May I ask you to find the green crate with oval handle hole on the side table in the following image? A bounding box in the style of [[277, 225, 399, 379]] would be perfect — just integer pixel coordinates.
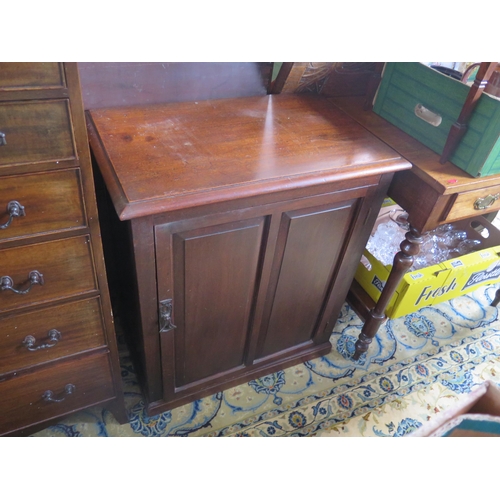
[[373, 63, 500, 177]]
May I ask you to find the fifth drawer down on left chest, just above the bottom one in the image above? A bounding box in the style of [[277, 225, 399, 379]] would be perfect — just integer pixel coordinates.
[[0, 297, 106, 374]]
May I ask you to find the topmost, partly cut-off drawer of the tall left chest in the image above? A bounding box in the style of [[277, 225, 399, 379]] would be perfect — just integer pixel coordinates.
[[0, 62, 65, 90]]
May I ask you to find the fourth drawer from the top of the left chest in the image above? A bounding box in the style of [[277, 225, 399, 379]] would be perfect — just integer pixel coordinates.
[[0, 235, 97, 312]]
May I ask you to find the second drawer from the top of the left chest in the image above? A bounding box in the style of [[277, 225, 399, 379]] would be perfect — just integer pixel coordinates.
[[0, 99, 76, 166]]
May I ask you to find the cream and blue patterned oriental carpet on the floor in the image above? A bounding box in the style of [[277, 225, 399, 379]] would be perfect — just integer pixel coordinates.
[[34, 286, 500, 437]]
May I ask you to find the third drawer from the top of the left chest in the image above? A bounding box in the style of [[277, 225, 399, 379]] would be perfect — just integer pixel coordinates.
[[0, 169, 86, 242]]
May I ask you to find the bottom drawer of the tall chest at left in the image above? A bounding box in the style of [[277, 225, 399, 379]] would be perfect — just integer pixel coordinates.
[[0, 353, 114, 434]]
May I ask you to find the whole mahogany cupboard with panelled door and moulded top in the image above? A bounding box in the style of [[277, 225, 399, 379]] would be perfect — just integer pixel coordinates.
[[87, 95, 410, 414]]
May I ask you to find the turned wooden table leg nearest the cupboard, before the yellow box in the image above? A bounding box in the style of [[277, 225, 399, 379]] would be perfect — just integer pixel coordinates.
[[353, 226, 422, 359]]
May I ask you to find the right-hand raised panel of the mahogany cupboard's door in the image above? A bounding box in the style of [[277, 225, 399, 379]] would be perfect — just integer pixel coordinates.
[[257, 201, 356, 358]]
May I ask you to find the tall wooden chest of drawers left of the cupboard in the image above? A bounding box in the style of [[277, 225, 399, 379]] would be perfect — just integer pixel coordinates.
[[0, 63, 127, 435]]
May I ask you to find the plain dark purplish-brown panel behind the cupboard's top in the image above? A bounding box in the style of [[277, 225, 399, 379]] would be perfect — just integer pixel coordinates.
[[78, 62, 272, 109]]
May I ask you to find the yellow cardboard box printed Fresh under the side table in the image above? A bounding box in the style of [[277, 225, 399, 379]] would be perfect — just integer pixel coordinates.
[[355, 217, 500, 318]]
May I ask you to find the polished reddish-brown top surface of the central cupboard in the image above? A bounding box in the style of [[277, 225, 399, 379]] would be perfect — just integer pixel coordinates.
[[88, 95, 411, 219]]
